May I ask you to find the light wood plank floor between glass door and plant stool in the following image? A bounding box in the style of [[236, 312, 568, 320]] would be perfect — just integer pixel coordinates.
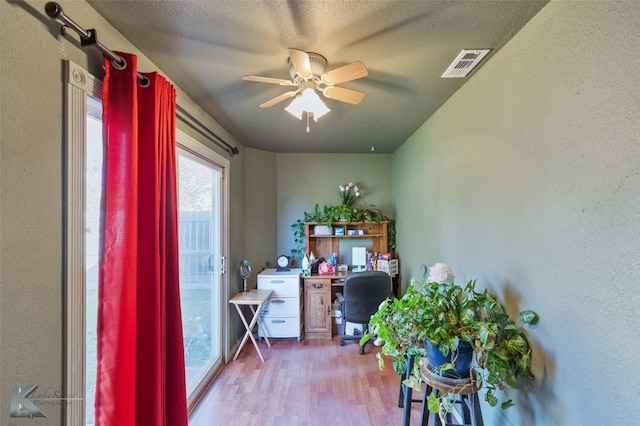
[[189, 337, 421, 426]]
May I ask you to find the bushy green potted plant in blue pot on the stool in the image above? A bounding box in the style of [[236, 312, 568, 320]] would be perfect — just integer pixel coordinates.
[[362, 263, 538, 417]]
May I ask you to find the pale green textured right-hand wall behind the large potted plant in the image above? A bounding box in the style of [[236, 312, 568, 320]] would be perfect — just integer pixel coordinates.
[[393, 1, 640, 426]]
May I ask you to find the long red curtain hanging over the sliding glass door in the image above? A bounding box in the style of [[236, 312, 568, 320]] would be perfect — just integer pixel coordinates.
[[95, 53, 187, 426]]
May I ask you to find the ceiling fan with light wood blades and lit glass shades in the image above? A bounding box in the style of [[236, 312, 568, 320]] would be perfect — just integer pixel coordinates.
[[243, 49, 368, 127]]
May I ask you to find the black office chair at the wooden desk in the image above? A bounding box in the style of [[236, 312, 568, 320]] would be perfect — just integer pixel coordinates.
[[336, 271, 393, 355]]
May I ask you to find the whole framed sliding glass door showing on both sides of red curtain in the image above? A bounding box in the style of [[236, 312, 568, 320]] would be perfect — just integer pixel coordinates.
[[69, 62, 229, 426]]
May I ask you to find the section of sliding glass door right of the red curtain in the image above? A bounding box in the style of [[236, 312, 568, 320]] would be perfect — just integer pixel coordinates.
[[177, 136, 225, 405]]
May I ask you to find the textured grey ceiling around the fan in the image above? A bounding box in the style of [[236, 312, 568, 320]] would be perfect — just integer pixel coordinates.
[[86, 0, 546, 153]]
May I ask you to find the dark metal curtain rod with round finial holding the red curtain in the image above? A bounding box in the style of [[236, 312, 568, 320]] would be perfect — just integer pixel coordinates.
[[44, 1, 240, 155]]
